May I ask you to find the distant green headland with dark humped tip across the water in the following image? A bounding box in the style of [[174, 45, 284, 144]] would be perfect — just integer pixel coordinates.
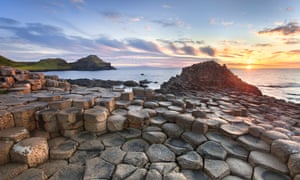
[[0, 55, 116, 71]]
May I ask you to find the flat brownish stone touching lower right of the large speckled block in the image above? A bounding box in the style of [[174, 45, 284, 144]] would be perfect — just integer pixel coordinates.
[[37, 160, 68, 178]]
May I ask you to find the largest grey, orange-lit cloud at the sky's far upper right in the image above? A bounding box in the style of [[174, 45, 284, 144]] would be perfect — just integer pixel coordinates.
[[258, 22, 300, 36]]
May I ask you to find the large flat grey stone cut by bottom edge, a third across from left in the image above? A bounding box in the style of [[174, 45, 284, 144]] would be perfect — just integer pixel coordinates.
[[83, 157, 115, 180]]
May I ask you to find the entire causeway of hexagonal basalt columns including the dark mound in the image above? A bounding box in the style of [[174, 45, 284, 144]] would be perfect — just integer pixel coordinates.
[[0, 62, 300, 180]]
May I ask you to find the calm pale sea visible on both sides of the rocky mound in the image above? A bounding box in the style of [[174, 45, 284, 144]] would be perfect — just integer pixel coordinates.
[[43, 66, 300, 104]]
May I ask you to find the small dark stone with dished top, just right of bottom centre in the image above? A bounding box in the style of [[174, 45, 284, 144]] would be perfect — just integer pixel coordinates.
[[165, 138, 193, 155]]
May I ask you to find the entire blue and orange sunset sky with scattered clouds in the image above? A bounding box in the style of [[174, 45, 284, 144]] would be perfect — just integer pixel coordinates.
[[0, 0, 300, 69]]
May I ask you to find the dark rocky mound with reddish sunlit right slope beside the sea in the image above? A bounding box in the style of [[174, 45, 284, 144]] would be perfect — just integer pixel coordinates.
[[161, 61, 262, 95]]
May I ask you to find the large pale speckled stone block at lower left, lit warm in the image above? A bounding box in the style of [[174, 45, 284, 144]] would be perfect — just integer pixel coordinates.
[[10, 137, 49, 167]]
